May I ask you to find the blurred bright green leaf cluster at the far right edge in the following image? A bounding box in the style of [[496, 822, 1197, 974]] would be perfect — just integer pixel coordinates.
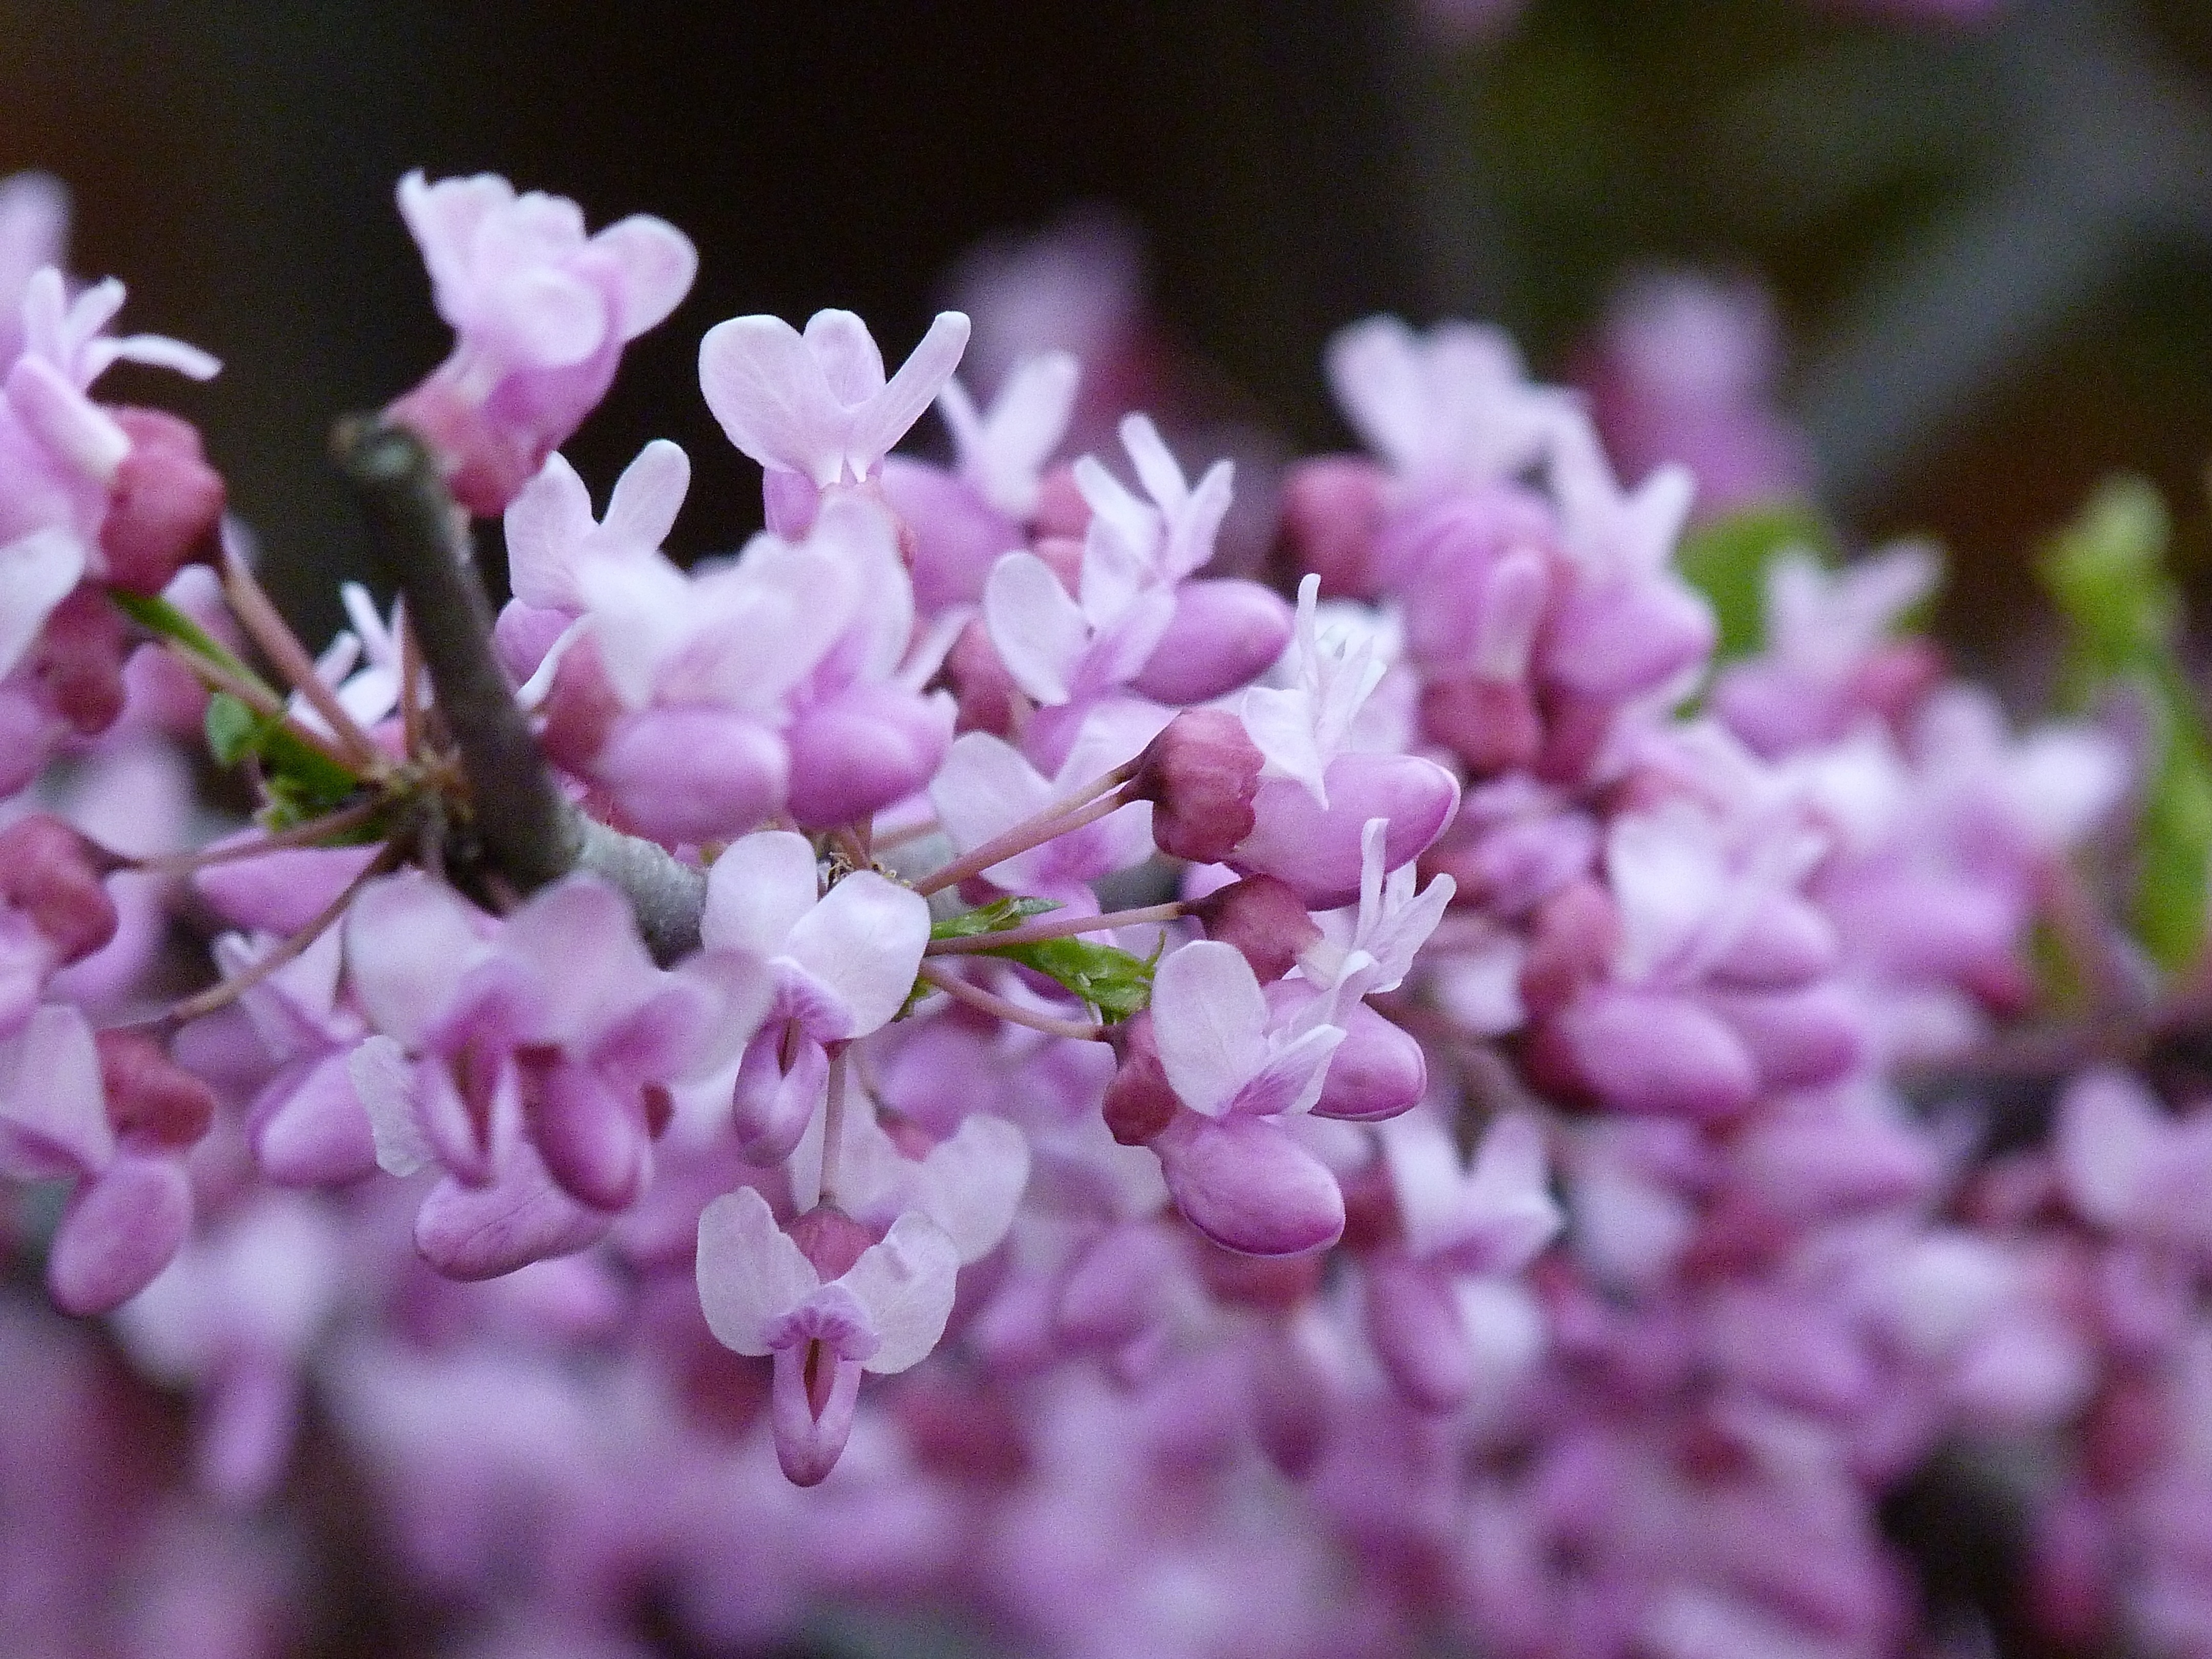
[[2039, 478, 2212, 971]]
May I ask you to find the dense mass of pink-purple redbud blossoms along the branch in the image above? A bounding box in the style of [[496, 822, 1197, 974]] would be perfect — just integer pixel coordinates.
[[0, 175, 2212, 1659]]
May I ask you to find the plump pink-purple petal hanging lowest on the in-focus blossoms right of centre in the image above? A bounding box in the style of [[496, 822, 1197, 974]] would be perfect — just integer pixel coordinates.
[[1153, 1113, 1345, 1257]]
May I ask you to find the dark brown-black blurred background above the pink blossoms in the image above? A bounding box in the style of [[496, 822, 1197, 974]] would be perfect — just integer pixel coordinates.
[[0, 0, 2212, 676]]
